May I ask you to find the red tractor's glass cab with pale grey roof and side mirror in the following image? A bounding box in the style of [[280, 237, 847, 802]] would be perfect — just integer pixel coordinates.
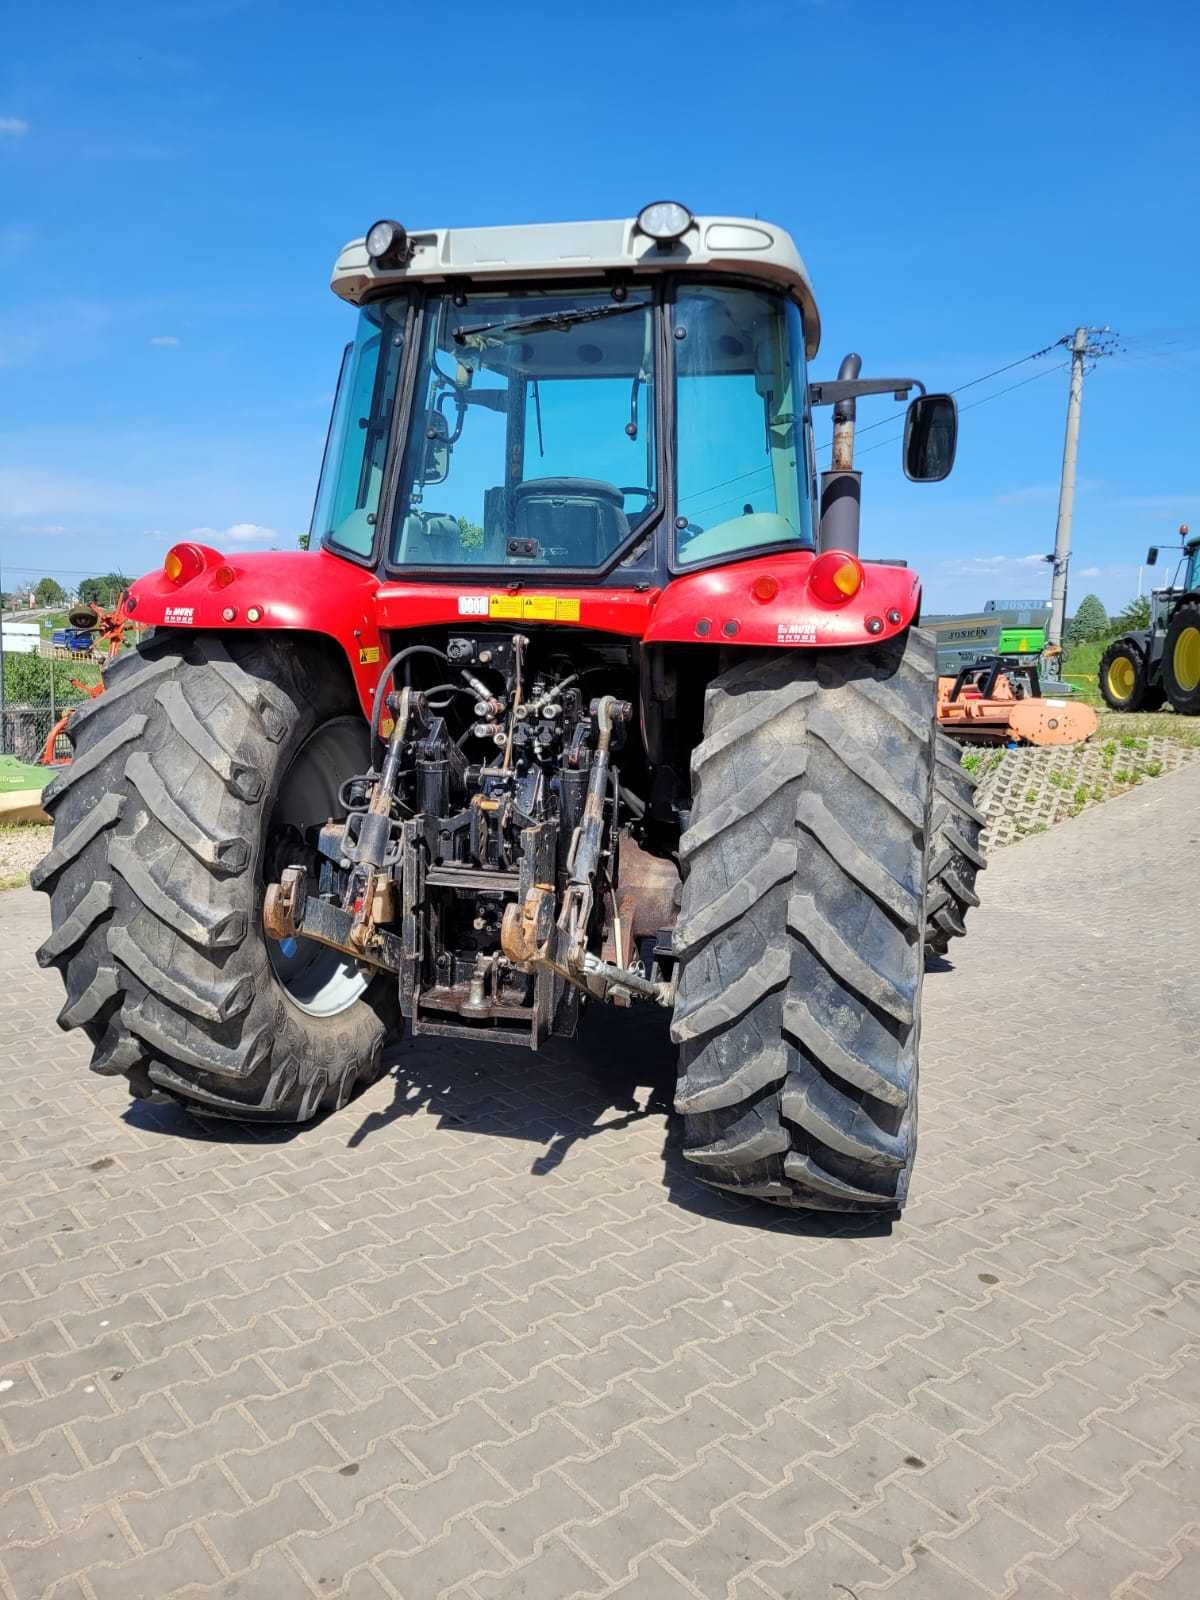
[[312, 203, 952, 587]]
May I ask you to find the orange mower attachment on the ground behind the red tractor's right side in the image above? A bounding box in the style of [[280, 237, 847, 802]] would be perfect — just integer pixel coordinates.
[[938, 656, 1099, 744]]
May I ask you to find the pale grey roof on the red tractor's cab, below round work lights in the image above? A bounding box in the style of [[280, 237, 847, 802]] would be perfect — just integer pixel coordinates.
[[330, 216, 821, 360]]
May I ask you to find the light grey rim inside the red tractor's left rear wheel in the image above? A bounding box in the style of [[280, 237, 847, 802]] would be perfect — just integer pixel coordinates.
[[264, 717, 370, 1016]]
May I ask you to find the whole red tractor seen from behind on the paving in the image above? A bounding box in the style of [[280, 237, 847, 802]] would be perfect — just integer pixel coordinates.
[[34, 202, 981, 1211]]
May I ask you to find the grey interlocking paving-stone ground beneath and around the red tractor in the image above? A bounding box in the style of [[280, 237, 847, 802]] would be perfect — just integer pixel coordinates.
[[0, 766, 1200, 1600]]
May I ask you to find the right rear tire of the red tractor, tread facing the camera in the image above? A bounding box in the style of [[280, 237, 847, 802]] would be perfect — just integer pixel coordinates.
[[672, 630, 934, 1213]]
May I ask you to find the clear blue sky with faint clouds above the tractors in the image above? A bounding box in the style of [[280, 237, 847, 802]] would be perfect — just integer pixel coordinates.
[[0, 0, 1200, 610]]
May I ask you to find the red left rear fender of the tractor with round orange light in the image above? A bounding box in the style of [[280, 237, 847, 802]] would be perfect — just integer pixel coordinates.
[[122, 544, 382, 717]]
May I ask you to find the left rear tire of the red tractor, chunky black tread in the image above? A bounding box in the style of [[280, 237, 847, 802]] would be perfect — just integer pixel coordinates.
[[30, 634, 397, 1122]]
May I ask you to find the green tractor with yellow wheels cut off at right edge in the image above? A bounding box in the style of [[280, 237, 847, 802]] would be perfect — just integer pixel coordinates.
[[1099, 523, 1200, 717]]
